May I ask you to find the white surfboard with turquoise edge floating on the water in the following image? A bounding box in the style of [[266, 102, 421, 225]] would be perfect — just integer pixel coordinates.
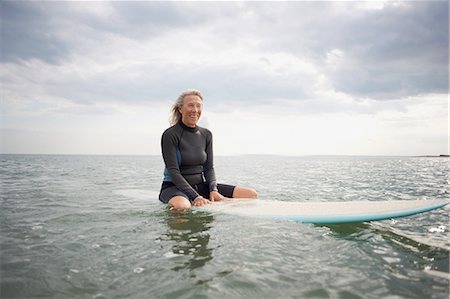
[[199, 198, 450, 224]]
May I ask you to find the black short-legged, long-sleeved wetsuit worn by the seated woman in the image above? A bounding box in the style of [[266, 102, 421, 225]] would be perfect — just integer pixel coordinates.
[[159, 121, 234, 203]]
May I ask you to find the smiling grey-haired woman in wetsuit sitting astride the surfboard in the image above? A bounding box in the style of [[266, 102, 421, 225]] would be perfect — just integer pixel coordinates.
[[159, 89, 257, 210]]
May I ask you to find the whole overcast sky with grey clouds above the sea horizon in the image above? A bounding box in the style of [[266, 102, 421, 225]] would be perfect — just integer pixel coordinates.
[[0, 1, 449, 155]]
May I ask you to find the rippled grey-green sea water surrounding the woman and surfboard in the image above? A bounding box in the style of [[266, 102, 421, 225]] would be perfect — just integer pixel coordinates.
[[0, 155, 450, 299]]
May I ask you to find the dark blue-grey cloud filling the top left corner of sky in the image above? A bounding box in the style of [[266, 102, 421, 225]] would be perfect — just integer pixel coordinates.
[[0, 1, 243, 63]]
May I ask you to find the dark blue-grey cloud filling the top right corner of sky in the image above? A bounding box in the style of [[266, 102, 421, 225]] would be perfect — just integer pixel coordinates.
[[255, 2, 449, 99]]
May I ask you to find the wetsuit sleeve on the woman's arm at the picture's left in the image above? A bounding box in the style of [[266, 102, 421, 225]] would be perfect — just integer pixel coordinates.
[[161, 131, 199, 200]]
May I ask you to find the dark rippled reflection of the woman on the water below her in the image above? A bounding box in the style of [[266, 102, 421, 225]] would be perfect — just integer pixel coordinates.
[[163, 211, 214, 271]]
